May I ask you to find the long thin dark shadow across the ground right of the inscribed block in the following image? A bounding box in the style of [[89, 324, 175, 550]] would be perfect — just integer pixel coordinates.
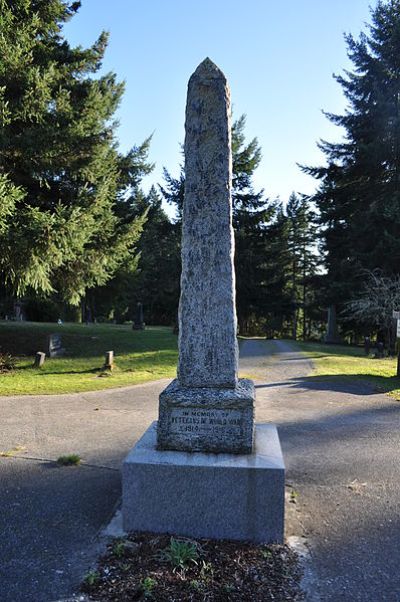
[[255, 374, 400, 398]]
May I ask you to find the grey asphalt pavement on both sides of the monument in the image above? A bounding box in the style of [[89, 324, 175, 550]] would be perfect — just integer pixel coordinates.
[[0, 340, 400, 602]]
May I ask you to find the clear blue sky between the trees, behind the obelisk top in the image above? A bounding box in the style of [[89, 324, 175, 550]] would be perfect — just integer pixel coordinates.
[[64, 0, 376, 200]]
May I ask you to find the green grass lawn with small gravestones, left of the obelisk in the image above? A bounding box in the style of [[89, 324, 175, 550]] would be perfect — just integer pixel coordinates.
[[0, 321, 178, 395]]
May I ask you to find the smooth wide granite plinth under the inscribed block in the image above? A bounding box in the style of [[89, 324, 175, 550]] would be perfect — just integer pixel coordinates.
[[122, 422, 285, 543]]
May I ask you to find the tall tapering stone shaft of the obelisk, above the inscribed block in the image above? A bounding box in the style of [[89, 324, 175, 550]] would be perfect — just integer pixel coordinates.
[[178, 59, 238, 387]]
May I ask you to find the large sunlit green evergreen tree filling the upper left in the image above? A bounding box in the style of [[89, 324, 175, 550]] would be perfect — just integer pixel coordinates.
[[0, 0, 151, 304]]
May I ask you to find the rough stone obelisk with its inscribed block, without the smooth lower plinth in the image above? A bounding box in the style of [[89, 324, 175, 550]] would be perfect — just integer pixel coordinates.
[[158, 59, 254, 453]]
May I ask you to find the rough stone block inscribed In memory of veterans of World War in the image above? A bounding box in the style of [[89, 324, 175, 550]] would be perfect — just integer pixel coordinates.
[[157, 379, 254, 454]]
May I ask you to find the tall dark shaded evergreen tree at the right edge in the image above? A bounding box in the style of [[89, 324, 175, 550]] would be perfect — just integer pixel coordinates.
[[303, 0, 400, 338]]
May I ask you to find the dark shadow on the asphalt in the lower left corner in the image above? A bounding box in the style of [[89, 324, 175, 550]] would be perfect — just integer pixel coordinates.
[[0, 450, 121, 602]]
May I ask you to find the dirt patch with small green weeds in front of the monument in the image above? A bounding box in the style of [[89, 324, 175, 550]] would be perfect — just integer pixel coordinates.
[[82, 533, 304, 602]]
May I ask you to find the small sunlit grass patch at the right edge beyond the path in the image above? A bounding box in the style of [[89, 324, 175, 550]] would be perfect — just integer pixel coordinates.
[[295, 342, 400, 400]]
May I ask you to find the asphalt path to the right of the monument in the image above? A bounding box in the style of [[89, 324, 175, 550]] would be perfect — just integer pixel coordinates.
[[241, 341, 400, 602]]
